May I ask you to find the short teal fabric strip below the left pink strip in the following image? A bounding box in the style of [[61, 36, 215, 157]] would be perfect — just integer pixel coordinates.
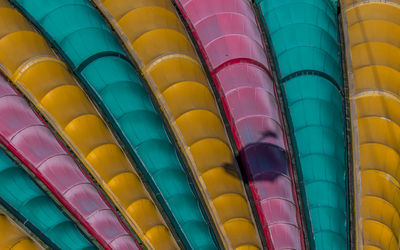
[[0, 150, 95, 249]]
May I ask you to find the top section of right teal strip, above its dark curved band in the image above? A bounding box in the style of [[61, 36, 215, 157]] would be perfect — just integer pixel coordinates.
[[260, 0, 342, 85]]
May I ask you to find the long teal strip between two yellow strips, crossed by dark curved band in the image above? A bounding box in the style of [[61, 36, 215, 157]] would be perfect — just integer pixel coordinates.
[[13, 0, 216, 249]]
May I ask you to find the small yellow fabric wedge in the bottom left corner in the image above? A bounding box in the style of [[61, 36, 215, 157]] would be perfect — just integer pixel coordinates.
[[0, 214, 40, 250]]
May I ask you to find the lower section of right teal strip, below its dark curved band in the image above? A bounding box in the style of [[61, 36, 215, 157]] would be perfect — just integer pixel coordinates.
[[284, 75, 348, 249]]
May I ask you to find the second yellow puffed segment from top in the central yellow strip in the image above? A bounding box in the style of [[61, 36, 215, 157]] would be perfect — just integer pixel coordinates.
[[118, 6, 184, 41]]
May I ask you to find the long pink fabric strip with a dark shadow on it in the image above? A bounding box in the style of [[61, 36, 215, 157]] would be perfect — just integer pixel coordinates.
[[175, 0, 304, 249]]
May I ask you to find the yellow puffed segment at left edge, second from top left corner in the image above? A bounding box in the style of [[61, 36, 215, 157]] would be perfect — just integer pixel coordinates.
[[0, 8, 33, 38]]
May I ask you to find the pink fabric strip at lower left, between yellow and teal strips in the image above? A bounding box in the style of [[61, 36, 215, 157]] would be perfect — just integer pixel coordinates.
[[0, 75, 139, 249]]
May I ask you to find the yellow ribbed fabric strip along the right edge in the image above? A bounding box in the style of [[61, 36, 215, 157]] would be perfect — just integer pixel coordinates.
[[342, 0, 400, 250]]
